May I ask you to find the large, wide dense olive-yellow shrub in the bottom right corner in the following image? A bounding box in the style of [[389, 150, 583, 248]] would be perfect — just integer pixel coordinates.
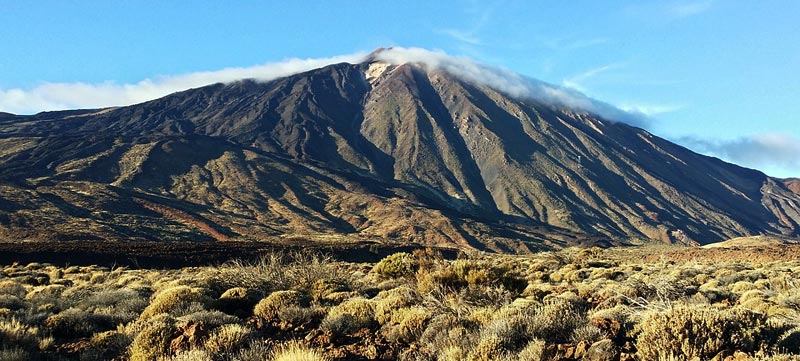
[[637, 306, 766, 360]]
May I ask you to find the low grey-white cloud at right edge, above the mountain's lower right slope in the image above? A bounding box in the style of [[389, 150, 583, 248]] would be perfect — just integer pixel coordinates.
[[678, 133, 800, 176]]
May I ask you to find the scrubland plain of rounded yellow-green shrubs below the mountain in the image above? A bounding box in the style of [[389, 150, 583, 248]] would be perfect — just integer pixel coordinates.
[[0, 243, 800, 361]]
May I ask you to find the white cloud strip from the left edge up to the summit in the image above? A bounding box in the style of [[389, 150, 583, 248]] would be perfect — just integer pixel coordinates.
[[0, 53, 367, 114]]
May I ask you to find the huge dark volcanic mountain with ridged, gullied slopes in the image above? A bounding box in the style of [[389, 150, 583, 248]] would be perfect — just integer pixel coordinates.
[[0, 56, 800, 252]]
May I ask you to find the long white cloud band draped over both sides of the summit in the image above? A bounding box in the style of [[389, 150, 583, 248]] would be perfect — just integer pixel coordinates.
[[0, 47, 647, 126]]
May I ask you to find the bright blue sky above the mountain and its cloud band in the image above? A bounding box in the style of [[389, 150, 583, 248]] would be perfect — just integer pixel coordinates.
[[0, 0, 800, 177]]
